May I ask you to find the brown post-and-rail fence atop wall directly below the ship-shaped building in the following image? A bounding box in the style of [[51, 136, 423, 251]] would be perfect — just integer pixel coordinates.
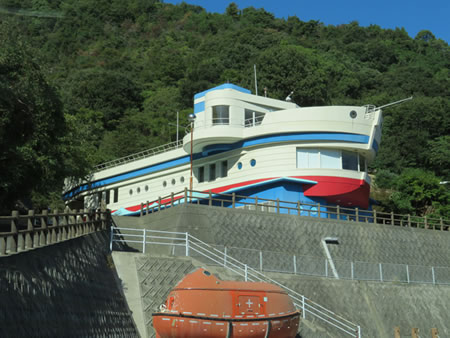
[[140, 189, 450, 231]]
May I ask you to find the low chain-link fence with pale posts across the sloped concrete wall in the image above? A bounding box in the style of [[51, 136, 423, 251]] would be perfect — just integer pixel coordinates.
[[179, 245, 450, 285]]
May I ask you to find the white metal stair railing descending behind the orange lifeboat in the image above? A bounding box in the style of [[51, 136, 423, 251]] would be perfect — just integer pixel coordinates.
[[110, 227, 361, 338]]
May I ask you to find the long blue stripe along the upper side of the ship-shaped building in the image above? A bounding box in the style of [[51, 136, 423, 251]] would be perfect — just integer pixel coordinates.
[[63, 133, 375, 200]]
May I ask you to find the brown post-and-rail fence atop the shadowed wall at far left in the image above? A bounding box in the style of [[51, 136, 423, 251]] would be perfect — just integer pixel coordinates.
[[0, 209, 111, 256]]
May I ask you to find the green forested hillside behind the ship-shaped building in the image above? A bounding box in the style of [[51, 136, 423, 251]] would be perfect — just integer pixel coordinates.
[[0, 0, 450, 217]]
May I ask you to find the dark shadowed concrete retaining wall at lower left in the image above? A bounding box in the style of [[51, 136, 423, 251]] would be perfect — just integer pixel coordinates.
[[0, 231, 139, 337]]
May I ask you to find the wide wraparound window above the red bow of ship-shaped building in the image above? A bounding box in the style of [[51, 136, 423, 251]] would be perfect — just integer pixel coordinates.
[[297, 148, 366, 171]]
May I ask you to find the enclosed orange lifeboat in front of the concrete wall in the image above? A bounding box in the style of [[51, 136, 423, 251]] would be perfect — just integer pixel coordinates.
[[153, 269, 300, 338]]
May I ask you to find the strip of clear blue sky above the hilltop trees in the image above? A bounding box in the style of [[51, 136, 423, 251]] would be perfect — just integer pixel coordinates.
[[163, 0, 450, 43]]
